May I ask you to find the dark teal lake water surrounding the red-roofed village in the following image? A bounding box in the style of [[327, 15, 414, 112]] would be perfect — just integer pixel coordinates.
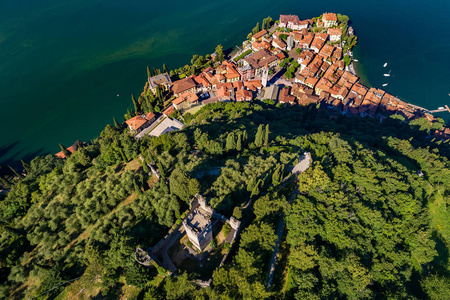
[[0, 0, 450, 163]]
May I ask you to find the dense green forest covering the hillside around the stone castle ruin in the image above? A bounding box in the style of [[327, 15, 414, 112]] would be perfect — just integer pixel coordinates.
[[0, 102, 450, 299]]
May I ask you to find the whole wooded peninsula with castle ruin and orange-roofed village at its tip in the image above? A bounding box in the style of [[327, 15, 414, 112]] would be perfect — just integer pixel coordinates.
[[0, 13, 450, 300]]
